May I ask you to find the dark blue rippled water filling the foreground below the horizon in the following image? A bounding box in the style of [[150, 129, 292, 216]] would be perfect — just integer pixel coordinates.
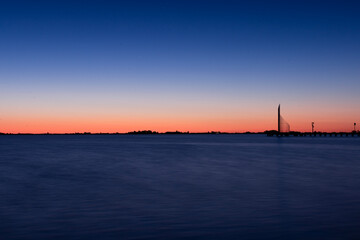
[[0, 135, 360, 240]]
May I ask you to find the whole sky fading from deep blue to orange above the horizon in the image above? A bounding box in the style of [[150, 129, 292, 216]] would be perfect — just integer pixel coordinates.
[[0, 0, 360, 133]]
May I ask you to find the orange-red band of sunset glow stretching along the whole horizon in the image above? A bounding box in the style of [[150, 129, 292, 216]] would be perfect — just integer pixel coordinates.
[[0, 114, 354, 133]]
